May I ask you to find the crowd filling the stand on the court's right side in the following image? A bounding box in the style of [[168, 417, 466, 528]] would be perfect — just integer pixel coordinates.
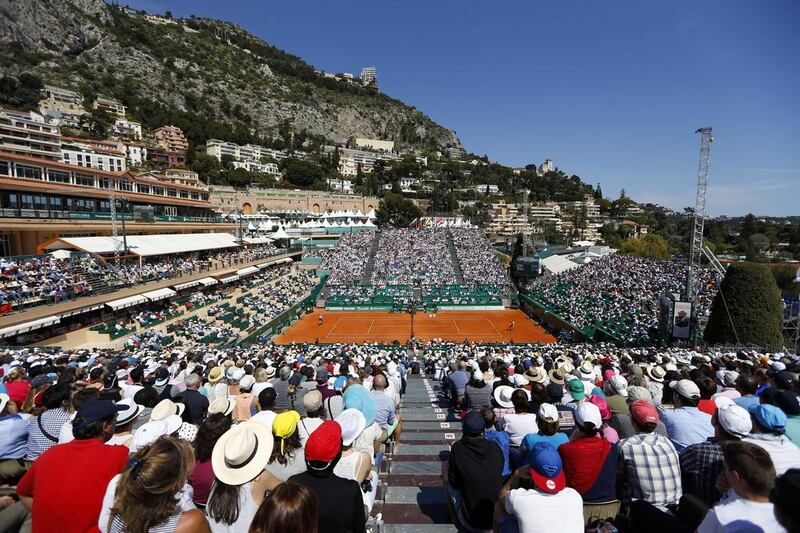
[[528, 254, 717, 344]]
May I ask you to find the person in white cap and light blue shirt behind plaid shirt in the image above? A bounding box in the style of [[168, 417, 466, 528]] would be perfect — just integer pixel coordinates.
[[661, 379, 714, 452]]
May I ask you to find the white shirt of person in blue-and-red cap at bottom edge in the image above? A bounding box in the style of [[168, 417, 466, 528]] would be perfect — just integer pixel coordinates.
[[505, 487, 584, 533]]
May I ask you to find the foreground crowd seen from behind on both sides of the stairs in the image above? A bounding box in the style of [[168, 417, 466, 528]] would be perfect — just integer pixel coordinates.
[[0, 343, 800, 533]]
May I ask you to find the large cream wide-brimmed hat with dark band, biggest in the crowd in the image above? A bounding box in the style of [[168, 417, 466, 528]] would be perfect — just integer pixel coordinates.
[[211, 422, 274, 486]]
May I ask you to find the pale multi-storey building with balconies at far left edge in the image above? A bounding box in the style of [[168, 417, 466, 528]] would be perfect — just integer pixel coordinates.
[[0, 108, 61, 161]]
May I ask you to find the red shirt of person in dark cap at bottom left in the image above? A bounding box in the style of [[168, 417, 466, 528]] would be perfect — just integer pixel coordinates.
[[17, 439, 128, 533]]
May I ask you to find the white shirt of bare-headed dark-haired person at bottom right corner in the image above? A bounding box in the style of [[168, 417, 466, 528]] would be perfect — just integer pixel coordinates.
[[697, 490, 786, 533]]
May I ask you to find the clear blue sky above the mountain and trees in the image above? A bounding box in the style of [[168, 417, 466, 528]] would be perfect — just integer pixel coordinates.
[[122, 0, 800, 215]]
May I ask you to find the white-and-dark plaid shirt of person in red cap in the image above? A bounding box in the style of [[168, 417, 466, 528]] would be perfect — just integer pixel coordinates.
[[619, 433, 683, 507]]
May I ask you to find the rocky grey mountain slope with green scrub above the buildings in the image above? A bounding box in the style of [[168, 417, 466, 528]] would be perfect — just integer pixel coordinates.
[[0, 0, 460, 149]]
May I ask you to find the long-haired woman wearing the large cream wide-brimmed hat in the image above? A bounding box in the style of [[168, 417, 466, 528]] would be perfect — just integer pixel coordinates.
[[206, 422, 274, 533]]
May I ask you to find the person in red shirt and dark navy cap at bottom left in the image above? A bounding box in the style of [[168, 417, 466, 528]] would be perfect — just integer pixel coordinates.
[[17, 400, 128, 531]]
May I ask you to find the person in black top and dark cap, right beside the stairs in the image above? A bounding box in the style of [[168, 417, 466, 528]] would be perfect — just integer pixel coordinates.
[[446, 408, 500, 529]]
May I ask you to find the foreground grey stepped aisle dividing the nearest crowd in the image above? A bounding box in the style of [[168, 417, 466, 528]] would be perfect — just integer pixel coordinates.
[[373, 375, 461, 533]]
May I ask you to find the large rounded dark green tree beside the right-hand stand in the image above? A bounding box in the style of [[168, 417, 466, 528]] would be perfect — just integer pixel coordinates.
[[704, 263, 783, 350]]
